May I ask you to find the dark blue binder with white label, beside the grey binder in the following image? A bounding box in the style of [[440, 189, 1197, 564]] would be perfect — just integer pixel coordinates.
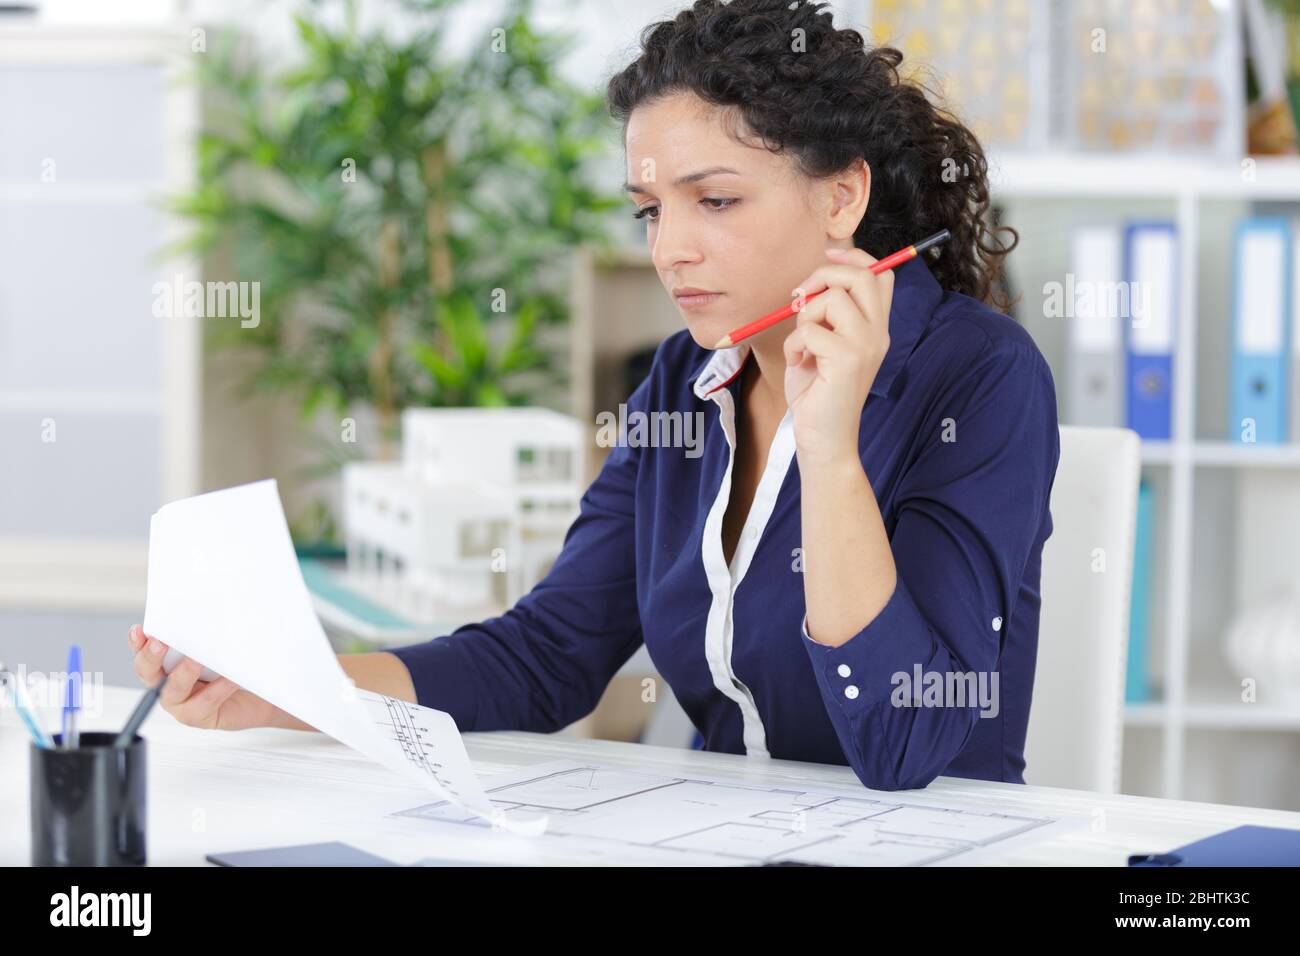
[[1125, 221, 1179, 440]]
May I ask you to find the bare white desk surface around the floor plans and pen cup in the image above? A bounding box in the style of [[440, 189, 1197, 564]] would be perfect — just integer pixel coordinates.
[[0, 685, 1300, 866]]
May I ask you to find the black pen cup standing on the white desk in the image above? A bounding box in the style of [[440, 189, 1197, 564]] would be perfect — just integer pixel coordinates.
[[31, 732, 146, 866]]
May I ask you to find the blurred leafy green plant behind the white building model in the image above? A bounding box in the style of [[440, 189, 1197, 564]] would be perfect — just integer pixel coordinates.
[[173, 0, 621, 538]]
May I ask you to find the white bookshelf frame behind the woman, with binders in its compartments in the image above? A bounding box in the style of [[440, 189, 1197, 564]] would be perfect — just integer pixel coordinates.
[[989, 152, 1300, 809]]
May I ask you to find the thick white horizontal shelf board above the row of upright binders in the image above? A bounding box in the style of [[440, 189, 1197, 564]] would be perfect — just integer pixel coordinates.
[[988, 151, 1300, 202]]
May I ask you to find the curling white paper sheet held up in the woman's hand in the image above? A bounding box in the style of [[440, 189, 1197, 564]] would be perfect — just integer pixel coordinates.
[[144, 480, 547, 835]]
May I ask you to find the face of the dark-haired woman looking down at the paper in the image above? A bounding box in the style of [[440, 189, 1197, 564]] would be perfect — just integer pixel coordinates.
[[625, 94, 855, 349]]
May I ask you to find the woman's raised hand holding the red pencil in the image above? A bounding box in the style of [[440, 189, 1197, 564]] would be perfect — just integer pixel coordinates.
[[785, 248, 893, 467]]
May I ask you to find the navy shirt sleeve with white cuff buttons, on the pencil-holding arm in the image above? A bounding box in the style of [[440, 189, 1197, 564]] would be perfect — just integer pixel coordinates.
[[802, 343, 1060, 790]]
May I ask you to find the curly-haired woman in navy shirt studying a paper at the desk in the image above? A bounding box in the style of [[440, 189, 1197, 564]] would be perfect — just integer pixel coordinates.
[[130, 0, 1058, 790]]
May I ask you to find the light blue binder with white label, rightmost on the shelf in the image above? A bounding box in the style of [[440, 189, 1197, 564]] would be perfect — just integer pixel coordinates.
[[1227, 217, 1294, 444]]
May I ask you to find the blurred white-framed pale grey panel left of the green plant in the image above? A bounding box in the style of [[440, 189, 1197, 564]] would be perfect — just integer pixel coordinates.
[[0, 18, 202, 680]]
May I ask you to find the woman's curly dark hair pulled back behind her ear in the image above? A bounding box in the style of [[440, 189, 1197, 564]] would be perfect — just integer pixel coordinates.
[[606, 0, 1019, 311]]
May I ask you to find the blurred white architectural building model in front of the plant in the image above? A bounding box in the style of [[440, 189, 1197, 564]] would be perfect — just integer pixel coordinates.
[[343, 407, 585, 623]]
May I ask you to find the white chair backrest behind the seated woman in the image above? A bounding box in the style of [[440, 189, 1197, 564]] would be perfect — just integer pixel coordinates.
[[1024, 425, 1141, 793]]
